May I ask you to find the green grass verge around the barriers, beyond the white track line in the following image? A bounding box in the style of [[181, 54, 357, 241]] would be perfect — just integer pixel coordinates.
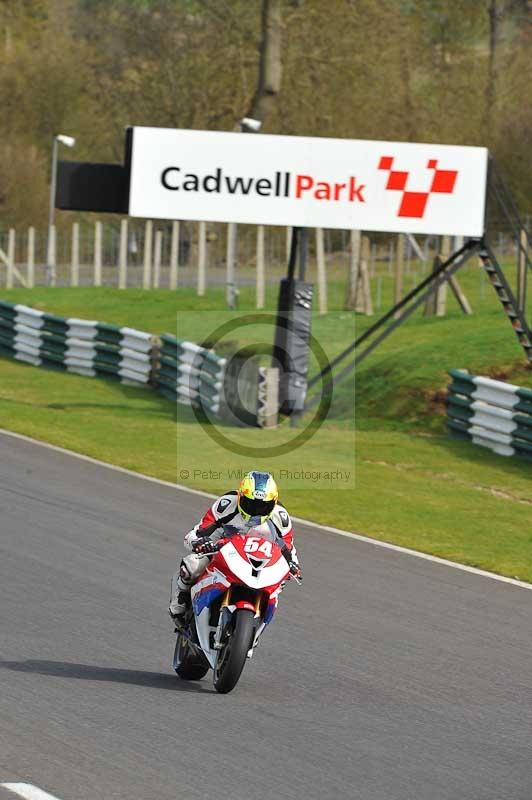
[[0, 289, 532, 581]]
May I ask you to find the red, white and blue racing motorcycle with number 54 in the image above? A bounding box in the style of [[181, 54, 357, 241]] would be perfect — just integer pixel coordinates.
[[173, 528, 301, 694]]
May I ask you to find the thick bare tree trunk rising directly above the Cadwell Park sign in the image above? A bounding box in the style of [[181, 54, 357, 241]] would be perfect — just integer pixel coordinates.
[[246, 0, 282, 121]]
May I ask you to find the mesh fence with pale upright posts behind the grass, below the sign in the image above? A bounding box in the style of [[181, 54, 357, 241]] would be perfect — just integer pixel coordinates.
[[0, 218, 528, 313]]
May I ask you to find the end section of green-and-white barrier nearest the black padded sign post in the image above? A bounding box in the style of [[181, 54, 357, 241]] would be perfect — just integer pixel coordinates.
[[154, 333, 226, 415]]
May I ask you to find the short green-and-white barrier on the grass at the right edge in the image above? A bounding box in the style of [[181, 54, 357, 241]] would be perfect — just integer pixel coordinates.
[[447, 369, 532, 461]]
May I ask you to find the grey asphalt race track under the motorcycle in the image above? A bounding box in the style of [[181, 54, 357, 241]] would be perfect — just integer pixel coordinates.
[[0, 435, 532, 800]]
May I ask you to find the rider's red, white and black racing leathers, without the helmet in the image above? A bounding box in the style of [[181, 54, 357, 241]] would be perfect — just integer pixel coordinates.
[[170, 491, 299, 616]]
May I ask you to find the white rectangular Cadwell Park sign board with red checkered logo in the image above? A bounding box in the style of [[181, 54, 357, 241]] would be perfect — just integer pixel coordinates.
[[128, 127, 488, 237]]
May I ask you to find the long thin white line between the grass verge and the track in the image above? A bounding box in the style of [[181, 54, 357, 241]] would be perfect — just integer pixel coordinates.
[[0, 428, 532, 589]]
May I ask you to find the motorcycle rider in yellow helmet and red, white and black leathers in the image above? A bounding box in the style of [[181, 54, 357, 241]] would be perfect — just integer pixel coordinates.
[[168, 470, 301, 627]]
